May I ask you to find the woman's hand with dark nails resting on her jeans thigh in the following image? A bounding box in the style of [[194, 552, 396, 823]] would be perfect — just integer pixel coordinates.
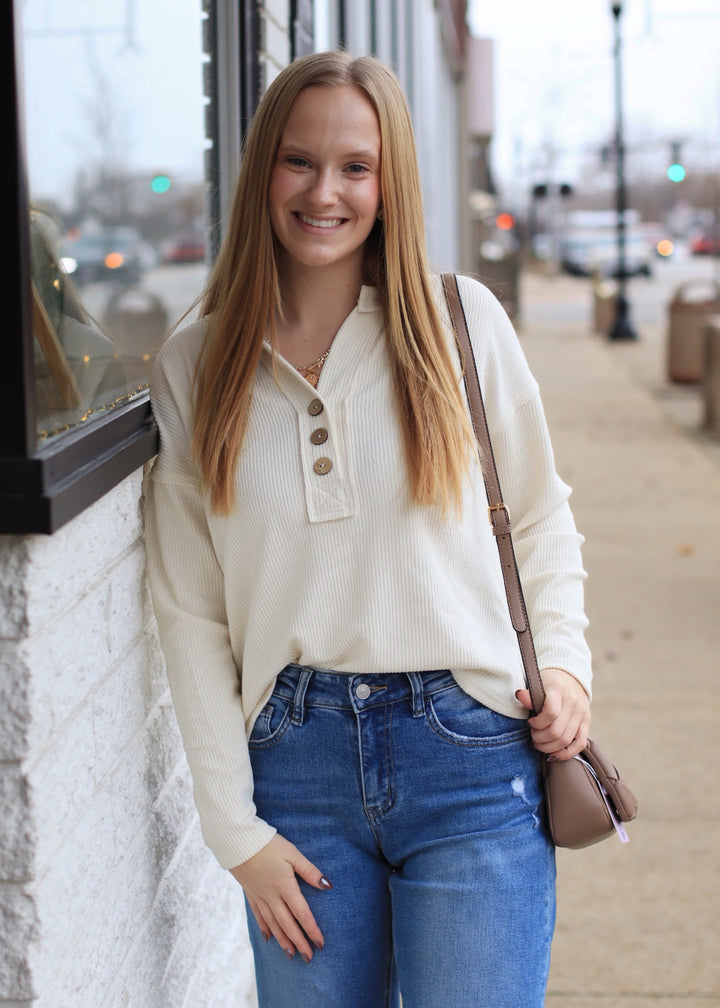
[[230, 834, 333, 963]]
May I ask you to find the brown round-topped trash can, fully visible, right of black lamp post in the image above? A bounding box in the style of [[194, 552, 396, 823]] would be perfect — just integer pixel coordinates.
[[668, 280, 720, 382]]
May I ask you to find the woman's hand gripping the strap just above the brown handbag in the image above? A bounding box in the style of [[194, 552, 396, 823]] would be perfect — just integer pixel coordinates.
[[515, 668, 590, 760]]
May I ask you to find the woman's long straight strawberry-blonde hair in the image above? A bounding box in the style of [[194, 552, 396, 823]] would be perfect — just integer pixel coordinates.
[[193, 51, 474, 515]]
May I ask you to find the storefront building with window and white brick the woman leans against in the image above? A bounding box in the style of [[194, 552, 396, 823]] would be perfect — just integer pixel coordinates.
[[0, 0, 480, 1008]]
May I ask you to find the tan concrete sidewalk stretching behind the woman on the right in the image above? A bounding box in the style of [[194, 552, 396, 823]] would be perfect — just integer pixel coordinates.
[[517, 277, 720, 1008]]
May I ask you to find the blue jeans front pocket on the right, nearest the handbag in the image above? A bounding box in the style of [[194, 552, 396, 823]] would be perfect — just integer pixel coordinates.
[[428, 683, 528, 746]]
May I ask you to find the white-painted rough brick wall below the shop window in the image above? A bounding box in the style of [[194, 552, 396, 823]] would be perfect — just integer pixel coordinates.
[[0, 473, 253, 1008]]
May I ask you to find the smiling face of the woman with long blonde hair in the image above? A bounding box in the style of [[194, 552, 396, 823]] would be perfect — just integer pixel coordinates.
[[269, 86, 380, 283]]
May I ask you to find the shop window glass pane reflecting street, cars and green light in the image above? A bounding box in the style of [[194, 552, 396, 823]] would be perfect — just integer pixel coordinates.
[[19, 0, 206, 440]]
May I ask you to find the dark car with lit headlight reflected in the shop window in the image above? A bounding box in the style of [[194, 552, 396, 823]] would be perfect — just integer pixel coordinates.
[[59, 228, 152, 285]]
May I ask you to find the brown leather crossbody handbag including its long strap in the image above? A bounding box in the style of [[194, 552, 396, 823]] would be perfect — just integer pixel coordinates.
[[443, 273, 637, 850]]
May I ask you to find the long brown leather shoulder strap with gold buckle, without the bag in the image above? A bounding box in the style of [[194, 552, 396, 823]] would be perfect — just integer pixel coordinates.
[[443, 273, 545, 714]]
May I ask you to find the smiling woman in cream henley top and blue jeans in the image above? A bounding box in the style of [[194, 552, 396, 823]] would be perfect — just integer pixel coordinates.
[[147, 52, 590, 1008]]
